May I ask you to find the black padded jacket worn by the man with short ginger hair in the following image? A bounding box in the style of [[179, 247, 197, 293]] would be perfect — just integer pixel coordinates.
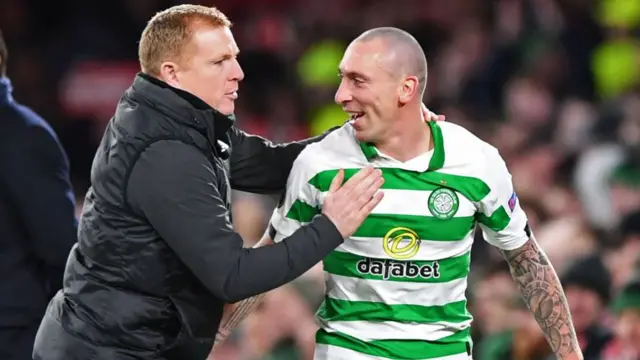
[[34, 75, 342, 360]]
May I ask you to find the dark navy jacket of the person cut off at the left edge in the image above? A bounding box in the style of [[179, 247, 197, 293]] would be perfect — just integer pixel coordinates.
[[0, 77, 77, 330]]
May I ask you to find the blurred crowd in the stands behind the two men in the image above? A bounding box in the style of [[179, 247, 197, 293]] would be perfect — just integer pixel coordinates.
[[0, 0, 640, 360]]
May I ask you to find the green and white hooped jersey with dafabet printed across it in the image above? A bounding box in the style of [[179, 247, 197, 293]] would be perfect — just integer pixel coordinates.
[[271, 122, 528, 360]]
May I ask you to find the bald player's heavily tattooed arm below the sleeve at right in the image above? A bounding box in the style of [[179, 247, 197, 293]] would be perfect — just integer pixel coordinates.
[[502, 238, 582, 359]]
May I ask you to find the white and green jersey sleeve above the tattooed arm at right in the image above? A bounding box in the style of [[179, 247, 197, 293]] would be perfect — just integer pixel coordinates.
[[477, 146, 530, 250]]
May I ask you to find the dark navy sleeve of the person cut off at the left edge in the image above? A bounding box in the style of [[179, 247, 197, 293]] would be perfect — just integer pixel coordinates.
[[0, 126, 78, 292]]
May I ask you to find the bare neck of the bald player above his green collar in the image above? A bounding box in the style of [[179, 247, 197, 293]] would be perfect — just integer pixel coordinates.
[[375, 107, 433, 162]]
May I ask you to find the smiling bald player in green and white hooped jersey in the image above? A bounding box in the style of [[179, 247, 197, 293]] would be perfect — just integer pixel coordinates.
[[215, 28, 582, 360]]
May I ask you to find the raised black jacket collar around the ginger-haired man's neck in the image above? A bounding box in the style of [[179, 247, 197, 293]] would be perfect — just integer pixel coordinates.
[[127, 73, 235, 144]]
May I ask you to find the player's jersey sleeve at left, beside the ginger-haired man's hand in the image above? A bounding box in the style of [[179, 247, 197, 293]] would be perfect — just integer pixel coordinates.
[[269, 153, 321, 242]]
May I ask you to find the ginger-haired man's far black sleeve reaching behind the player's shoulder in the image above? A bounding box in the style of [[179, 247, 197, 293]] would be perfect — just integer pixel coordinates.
[[229, 127, 337, 194]]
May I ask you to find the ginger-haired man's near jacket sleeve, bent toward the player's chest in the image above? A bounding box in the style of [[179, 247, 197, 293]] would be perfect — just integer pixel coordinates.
[[127, 140, 343, 302]]
